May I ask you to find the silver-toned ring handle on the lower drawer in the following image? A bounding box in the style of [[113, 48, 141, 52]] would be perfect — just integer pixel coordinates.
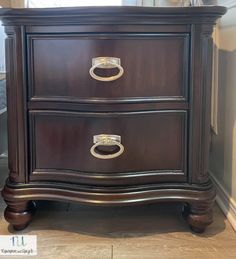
[[90, 134, 125, 159]]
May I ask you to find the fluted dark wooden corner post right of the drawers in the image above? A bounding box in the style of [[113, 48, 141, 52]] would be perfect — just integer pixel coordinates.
[[189, 25, 213, 183]]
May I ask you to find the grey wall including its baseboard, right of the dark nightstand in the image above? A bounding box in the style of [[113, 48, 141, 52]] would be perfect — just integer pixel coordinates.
[[210, 1, 236, 232]]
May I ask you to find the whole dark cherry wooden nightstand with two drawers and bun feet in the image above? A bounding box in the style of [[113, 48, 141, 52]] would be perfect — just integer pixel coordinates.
[[0, 6, 226, 232]]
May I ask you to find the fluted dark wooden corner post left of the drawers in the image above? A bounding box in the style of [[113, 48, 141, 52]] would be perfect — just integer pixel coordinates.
[[5, 26, 28, 182]]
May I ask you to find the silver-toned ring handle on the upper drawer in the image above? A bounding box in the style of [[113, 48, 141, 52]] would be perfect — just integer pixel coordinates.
[[89, 57, 124, 82]]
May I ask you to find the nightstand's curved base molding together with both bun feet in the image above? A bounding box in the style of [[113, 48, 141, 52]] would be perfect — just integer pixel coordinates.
[[2, 182, 215, 233]]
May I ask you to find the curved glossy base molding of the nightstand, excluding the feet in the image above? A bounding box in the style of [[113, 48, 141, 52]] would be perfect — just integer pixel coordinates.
[[3, 181, 215, 206]]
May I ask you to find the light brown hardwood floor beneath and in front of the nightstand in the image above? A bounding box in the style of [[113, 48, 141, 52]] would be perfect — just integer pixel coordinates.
[[0, 195, 236, 259]]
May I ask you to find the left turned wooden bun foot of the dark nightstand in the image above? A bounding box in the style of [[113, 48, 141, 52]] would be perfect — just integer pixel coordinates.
[[4, 201, 36, 230]]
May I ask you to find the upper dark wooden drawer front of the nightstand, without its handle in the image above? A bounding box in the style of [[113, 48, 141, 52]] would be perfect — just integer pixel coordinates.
[[28, 33, 189, 103]]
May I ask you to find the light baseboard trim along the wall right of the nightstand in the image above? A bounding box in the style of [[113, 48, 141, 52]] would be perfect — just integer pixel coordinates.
[[210, 172, 236, 231]]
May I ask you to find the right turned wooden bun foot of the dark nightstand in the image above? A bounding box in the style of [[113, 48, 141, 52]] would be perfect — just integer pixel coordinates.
[[182, 203, 213, 233]]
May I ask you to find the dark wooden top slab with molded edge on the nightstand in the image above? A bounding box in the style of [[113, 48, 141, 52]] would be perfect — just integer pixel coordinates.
[[0, 6, 227, 26]]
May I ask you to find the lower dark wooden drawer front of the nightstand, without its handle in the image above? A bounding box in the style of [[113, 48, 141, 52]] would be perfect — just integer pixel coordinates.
[[30, 111, 187, 185]]
